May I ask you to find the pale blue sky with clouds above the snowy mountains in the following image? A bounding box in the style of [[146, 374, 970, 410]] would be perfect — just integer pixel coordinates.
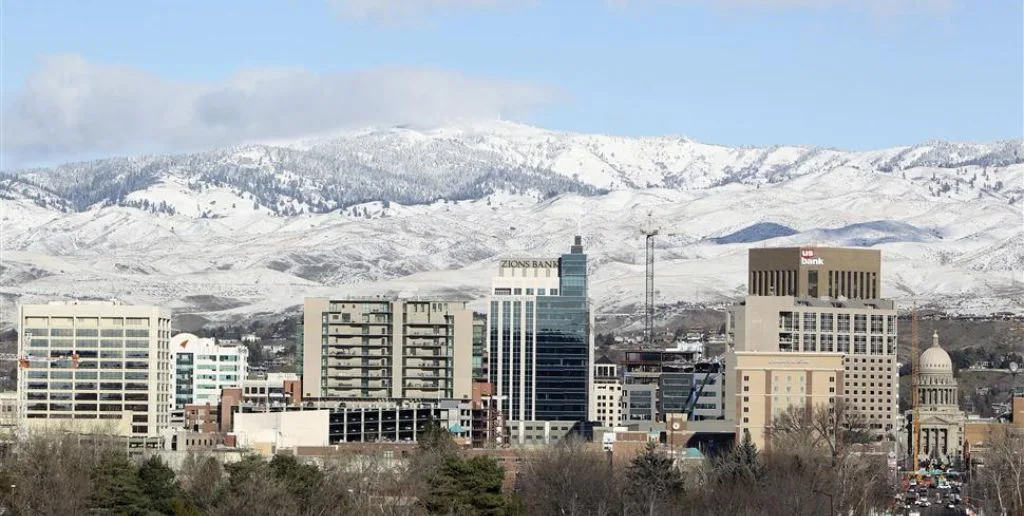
[[0, 0, 1024, 164]]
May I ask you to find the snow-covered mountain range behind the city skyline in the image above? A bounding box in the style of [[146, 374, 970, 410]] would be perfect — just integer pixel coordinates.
[[0, 122, 1024, 327]]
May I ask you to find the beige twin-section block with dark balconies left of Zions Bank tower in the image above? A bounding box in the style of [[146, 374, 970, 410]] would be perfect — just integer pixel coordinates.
[[302, 298, 473, 401]]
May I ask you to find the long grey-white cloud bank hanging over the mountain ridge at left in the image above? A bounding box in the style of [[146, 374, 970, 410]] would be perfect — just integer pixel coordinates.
[[3, 55, 553, 163]]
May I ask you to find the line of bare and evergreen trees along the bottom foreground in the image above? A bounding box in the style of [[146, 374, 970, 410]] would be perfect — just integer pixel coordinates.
[[0, 409, 1024, 516]]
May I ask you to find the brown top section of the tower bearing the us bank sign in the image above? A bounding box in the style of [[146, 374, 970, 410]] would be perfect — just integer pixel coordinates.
[[748, 247, 882, 299]]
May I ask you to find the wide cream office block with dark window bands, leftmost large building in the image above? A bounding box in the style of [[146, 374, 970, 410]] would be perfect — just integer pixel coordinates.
[[17, 301, 173, 437]]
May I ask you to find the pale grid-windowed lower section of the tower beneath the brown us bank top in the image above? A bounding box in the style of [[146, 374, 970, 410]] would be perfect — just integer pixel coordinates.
[[730, 296, 899, 432]]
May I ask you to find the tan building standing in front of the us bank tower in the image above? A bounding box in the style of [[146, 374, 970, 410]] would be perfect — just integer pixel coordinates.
[[725, 350, 844, 448]]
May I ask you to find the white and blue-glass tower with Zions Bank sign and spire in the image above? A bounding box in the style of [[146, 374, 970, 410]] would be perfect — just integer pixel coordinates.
[[487, 237, 594, 421]]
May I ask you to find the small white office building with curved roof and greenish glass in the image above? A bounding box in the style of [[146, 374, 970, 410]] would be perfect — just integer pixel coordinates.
[[171, 333, 249, 424]]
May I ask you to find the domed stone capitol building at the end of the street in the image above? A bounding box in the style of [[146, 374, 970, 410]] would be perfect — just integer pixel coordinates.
[[911, 333, 967, 466]]
